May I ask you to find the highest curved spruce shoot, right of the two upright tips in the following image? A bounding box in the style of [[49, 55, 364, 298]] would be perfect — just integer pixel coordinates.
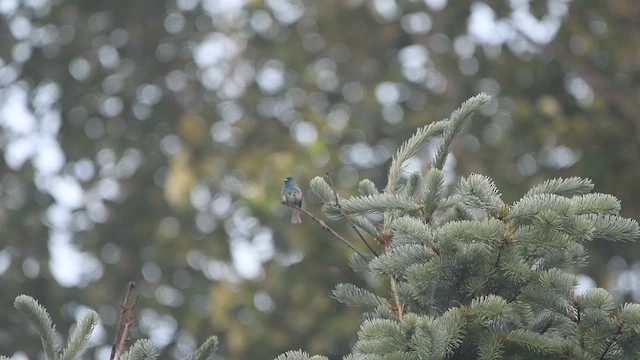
[[433, 93, 491, 170]]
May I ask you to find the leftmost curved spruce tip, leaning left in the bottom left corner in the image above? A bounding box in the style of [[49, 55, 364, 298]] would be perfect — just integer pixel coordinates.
[[13, 295, 58, 360]]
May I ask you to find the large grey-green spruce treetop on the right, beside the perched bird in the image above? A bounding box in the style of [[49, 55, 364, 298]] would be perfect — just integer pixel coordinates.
[[278, 94, 640, 360]]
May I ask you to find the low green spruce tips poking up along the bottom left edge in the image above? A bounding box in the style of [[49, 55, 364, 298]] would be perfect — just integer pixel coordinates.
[[0, 295, 218, 360]]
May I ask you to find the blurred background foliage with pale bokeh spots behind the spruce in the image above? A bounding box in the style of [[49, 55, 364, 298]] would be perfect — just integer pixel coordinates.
[[0, 0, 640, 359]]
